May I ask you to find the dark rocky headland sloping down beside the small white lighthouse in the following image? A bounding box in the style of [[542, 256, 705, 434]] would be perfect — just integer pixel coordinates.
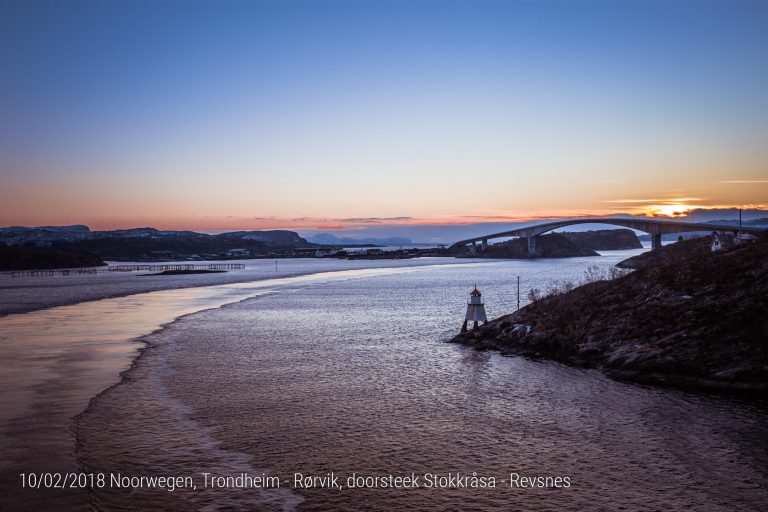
[[452, 237, 768, 396]]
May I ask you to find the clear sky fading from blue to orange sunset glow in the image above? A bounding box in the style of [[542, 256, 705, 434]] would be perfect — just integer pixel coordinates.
[[0, 0, 768, 239]]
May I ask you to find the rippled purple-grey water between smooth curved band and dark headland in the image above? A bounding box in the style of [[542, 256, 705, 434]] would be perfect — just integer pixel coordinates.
[[0, 254, 768, 511]]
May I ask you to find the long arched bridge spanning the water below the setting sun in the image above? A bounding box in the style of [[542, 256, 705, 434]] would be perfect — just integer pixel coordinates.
[[450, 217, 765, 255]]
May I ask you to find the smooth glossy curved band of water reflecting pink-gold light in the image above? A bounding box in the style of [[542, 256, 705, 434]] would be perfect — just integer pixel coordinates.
[[0, 262, 460, 510]]
